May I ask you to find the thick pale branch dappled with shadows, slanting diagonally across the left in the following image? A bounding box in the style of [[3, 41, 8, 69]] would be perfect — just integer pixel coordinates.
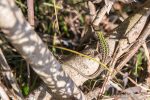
[[0, 0, 85, 100]]
